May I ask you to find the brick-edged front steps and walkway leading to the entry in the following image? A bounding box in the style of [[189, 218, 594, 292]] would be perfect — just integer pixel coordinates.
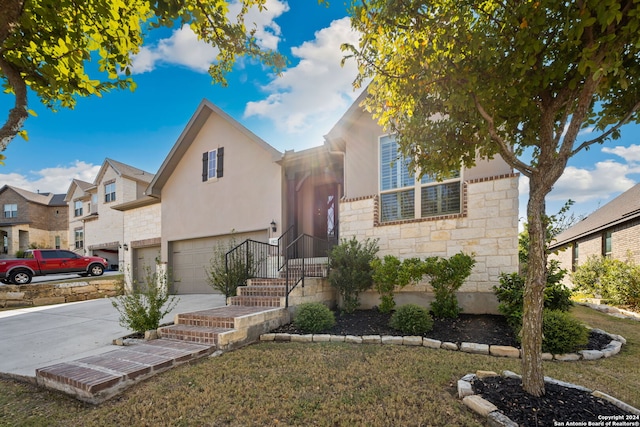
[[36, 265, 335, 404]]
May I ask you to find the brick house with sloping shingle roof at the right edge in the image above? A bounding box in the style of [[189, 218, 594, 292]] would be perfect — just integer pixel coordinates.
[[549, 184, 640, 284]]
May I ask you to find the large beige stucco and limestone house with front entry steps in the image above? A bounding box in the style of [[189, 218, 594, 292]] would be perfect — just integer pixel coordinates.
[[147, 95, 518, 313]]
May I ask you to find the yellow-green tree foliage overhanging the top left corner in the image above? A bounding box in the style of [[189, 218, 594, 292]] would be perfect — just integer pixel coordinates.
[[0, 0, 284, 154]]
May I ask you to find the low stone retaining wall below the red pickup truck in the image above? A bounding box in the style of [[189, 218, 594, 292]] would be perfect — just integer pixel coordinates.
[[0, 278, 122, 308]]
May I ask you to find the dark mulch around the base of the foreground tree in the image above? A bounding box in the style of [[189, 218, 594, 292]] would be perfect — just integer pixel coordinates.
[[472, 377, 630, 426]]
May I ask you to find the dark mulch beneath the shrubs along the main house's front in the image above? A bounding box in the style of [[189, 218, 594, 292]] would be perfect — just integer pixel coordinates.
[[272, 309, 611, 350]]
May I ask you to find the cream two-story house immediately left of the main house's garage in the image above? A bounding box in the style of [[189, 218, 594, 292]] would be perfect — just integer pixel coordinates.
[[65, 159, 157, 270]]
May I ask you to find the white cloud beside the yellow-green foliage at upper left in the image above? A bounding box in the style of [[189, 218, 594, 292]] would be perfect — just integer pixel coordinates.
[[131, 0, 289, 74]]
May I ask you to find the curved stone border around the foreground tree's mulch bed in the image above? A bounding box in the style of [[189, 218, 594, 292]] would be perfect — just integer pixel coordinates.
[[458, 371, 640, 427]]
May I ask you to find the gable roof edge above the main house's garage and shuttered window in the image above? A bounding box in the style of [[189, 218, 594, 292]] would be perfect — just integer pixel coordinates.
[[145, 99, 282, 197]]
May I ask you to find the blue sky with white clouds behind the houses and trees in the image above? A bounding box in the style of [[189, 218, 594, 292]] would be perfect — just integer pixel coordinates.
[[0, 0, 640, 226]]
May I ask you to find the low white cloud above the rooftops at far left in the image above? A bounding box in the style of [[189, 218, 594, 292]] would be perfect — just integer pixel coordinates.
[[0, 160, 101, 194]]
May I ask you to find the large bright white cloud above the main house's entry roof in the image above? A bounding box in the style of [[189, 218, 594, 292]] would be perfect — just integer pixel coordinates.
[[244, 18, 359, 142]]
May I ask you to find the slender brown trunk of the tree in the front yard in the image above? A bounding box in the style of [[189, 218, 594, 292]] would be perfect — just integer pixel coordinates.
[[522, 177, 547, 397]]
